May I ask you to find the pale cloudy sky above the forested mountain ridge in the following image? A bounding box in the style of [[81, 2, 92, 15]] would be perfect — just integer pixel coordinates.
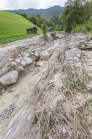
[[0, 0, 67, 10]]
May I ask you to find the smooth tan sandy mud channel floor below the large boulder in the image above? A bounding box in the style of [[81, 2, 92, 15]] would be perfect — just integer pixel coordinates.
[[0, 67, 42, 135]]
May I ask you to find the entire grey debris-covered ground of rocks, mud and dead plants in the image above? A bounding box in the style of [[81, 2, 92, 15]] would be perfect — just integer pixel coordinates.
[[0, 33, 92, 139]]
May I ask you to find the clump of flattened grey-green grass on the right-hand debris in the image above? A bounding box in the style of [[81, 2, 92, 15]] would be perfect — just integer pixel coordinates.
[[66, 55, 90, 92]]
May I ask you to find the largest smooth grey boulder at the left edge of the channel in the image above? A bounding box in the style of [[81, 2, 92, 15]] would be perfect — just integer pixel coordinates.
[[0, 71, 18, 85]]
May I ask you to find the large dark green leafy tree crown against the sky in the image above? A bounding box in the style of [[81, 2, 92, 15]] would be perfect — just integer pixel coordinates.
[[61, 0, 90, 32]]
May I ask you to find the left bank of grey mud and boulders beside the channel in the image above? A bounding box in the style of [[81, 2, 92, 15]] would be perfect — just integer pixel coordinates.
[[0, 34, 53, 85]]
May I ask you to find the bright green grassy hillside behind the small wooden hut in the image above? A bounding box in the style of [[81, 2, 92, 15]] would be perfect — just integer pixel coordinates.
[[0, 11, 42, 44]]
